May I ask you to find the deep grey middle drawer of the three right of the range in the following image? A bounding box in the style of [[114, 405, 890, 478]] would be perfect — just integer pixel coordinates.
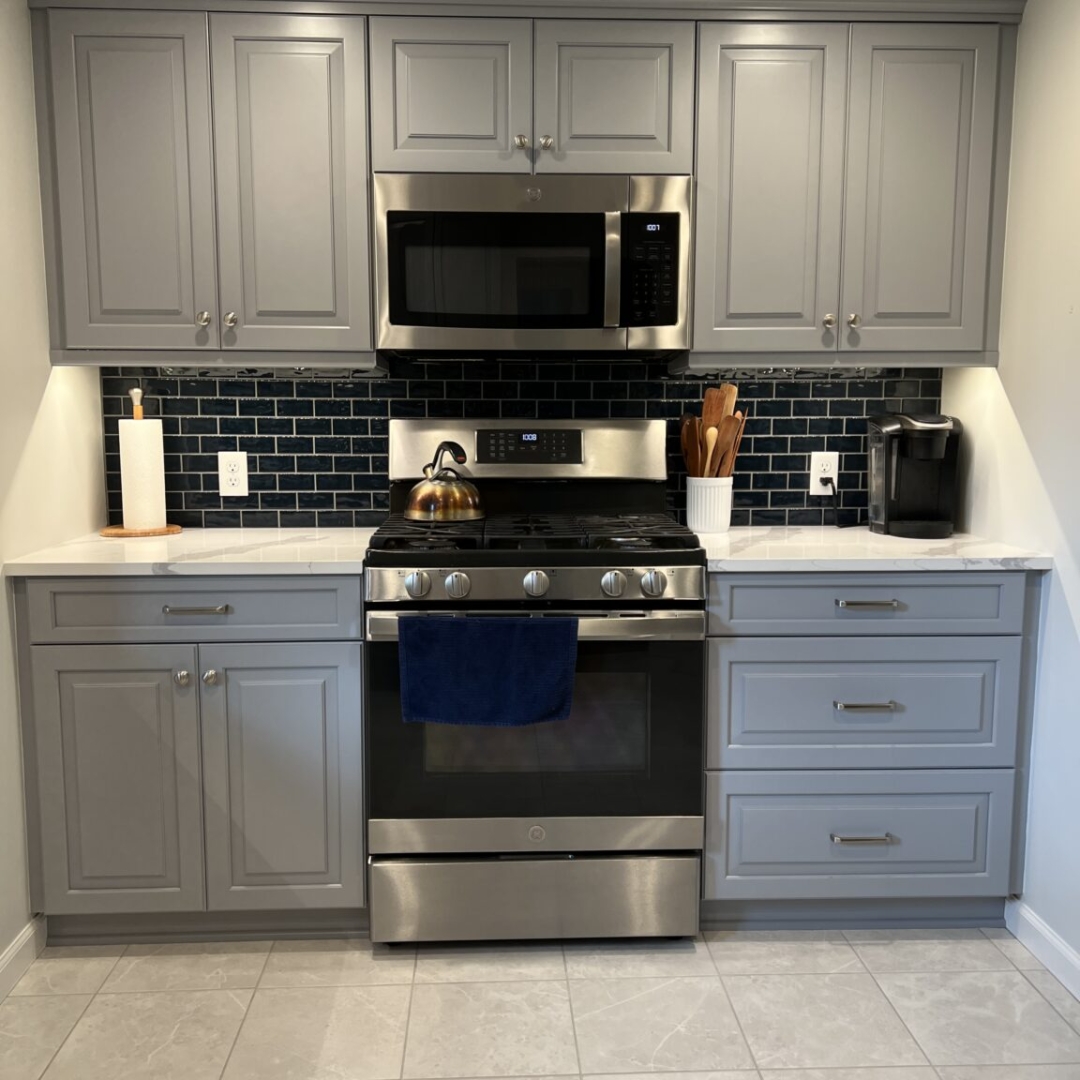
[[706, 636, 1021, 769]]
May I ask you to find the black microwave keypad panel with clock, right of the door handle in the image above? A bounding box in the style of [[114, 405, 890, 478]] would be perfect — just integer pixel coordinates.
[[620, 214, 679, 326]]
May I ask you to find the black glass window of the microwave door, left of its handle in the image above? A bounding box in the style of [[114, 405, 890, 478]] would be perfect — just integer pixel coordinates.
[[387, 211, 605, 329]]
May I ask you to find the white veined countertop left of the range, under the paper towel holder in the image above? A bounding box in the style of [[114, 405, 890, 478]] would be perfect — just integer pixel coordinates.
[[3, 529, 375, 578]]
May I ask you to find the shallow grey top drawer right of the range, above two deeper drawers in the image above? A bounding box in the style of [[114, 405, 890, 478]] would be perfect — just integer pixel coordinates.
[[708, 571, 1024, 637]]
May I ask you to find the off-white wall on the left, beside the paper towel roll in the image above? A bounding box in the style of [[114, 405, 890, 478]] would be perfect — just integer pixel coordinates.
[[0, 0, 105, 967]]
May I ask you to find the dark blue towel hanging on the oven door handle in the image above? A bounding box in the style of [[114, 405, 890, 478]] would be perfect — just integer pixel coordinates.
[[397, 616, 578, 728]]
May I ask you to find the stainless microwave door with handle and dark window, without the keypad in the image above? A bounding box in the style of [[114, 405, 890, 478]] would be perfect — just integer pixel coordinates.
[[375, 174, 629, 352]]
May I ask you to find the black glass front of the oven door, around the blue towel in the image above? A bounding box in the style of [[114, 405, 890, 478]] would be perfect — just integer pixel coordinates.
[[364, 640, 705, 818]]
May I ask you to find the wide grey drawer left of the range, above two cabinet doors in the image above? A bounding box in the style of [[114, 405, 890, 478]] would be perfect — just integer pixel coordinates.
[[27, 577, 361, 644]]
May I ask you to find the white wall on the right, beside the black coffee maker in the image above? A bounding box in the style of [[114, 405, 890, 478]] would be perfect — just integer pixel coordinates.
[[943, 0, 1080, 991]]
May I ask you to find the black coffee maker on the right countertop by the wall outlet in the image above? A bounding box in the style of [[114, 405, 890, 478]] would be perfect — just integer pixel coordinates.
[[866, 414, 963, 540]]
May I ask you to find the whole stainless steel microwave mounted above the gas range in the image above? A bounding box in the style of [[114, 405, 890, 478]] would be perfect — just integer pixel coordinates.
[[375, 173, 691, 355]]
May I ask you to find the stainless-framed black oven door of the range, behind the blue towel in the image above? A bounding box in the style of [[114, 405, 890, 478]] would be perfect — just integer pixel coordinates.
[[365, 611, 705, 854]]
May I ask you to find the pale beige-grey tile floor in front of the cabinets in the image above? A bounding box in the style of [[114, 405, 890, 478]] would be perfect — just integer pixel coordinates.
[[0, 930, 1080, 1080]]
